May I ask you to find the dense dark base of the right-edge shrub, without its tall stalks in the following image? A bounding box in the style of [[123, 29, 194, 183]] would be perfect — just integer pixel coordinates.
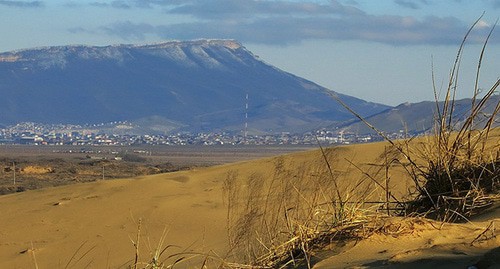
[[408, 130, 500, 221]]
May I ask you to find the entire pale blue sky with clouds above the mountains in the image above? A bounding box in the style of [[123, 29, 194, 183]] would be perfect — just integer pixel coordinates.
[[0, 0, 500, 105]]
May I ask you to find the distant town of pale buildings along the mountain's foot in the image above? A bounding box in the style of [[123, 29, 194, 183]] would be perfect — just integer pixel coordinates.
[[0, 122, 414, 146]]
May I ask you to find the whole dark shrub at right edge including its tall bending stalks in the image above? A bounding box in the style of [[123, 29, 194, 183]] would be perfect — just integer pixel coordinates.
[[332, 16, 500, 221]]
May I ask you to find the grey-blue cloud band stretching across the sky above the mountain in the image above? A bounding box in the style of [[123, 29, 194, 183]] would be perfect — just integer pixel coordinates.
[[78, 0, 500, 46]]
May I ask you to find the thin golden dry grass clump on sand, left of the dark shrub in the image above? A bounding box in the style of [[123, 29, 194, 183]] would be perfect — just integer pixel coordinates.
[[223, 148, 374, 268]]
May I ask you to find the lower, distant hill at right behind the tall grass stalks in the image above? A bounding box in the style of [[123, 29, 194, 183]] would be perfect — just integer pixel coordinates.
[[336, 95, 500, 134]]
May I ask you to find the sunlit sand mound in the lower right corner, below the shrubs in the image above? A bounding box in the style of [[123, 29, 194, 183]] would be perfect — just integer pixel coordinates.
[[314, 213, 500, 269]]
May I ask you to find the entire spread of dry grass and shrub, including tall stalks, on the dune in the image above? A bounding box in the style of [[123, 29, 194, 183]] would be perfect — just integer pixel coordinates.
[[224, 16, 500, 268]]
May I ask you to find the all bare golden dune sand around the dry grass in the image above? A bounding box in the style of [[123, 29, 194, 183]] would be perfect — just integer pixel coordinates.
[[0, 143, 500, 269]]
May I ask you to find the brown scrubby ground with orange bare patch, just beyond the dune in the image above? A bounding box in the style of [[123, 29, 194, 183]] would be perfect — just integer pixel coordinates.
[[0, 154, 187, 195]]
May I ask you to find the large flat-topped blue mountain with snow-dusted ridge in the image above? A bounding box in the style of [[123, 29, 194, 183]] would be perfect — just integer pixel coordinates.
[[0, 40, 389, 133]]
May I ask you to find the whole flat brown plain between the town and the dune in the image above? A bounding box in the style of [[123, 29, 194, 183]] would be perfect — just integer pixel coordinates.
[[0, 145, 308, 194]]
